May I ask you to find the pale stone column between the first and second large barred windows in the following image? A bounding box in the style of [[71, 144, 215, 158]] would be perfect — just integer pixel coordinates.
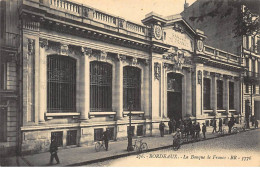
[[80, 47, 92, 121]]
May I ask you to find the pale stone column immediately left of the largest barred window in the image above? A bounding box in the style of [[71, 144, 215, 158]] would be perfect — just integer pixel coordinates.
[[38, 39, 48, 123]]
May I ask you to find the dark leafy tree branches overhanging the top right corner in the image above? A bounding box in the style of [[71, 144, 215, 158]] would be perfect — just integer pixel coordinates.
[[189, 0, 260, 37]]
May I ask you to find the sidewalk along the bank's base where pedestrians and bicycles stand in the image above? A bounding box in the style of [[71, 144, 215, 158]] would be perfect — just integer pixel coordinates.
[[1, 124, 256, 167]]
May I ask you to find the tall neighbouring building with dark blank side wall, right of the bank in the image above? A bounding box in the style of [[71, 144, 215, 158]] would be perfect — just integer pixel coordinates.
[[182, 0, 260, 119]]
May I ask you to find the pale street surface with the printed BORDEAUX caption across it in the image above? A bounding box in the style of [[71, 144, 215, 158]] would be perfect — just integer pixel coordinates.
[[86, 129, 260, 167]]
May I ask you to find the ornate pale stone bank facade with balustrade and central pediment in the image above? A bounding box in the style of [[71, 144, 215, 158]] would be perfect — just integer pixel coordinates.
[[0, 0, 243, 153]]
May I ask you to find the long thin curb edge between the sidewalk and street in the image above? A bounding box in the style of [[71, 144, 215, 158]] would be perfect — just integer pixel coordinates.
[[65, 129, 256, 167]]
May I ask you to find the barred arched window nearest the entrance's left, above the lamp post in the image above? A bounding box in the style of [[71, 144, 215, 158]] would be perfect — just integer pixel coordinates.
[[123, 66, 141, 111]]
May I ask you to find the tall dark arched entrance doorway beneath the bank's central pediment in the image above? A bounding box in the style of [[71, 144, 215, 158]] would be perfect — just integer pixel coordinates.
[[167, 73, 182, 121]]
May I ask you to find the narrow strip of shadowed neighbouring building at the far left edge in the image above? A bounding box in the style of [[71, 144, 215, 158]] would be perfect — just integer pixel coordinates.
[[0, 1, 20, 156]]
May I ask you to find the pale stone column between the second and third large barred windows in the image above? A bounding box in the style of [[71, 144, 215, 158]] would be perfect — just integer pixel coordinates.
[[115, 54, 126, 120]]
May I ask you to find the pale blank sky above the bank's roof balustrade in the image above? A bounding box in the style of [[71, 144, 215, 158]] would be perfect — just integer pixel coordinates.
[[74, 0, 196, 23]]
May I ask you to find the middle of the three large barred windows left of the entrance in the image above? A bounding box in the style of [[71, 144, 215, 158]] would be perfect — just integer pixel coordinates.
[[90, 61, 112, 112]]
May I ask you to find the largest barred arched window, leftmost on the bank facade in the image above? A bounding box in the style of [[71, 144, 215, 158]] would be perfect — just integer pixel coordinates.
[[47, 55, 76, 112]]
